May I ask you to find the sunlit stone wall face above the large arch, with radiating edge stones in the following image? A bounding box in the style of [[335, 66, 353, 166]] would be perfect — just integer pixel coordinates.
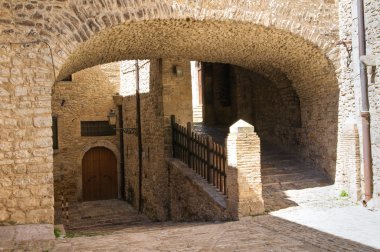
[[1, 0, 338, 69]]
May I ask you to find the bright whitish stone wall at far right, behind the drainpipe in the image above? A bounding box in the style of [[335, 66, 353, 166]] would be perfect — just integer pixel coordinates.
[[337, 1, 380, 206]]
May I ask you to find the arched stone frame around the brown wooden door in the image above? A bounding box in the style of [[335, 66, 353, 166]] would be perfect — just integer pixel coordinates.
[[76, 140, 122, 202]]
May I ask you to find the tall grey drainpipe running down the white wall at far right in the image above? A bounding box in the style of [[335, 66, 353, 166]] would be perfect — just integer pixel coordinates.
[[357, 0, 372, 204]]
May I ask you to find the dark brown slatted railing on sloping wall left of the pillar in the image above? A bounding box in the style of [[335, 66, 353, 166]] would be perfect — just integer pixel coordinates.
[[171, 116, 227, 194]]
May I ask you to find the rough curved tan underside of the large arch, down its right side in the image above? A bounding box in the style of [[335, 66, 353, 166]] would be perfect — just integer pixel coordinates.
[[58, 19, 339, 179]]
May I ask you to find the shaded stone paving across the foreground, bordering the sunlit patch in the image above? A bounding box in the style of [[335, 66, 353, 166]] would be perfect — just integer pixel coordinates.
[[53, 215, 376, 252]]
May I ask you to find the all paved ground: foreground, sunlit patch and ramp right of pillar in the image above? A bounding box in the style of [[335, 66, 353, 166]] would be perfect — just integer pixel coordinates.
[[53, 128, 380, 252]]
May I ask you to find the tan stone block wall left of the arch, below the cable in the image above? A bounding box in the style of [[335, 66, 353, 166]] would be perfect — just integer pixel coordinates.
[[0, 44, 54, 226]]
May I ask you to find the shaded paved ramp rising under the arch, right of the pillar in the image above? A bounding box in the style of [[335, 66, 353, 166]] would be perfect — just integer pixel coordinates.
[[261, 143, 331, 212]]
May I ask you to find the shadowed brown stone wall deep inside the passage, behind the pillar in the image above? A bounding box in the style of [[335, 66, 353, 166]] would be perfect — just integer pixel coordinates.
[[235, 68, 307, 151]]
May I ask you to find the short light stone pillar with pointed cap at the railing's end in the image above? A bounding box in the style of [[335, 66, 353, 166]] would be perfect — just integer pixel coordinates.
[[226, 120, 264, 220]]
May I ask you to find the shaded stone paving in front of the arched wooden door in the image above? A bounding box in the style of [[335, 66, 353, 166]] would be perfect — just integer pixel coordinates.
[[62, 199, 150, 233]]
